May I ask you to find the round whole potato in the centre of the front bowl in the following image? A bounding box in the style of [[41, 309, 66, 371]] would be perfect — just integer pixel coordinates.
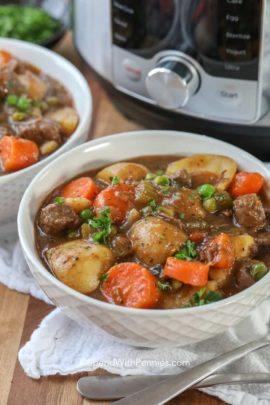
[[129, 217, 187, 266]]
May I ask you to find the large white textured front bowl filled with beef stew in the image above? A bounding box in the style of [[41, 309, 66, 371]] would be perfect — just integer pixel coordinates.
[[19, 131, 270, 347]]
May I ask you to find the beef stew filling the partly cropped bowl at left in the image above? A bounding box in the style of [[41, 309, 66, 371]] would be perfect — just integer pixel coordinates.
[[0, 50, 78, 175]]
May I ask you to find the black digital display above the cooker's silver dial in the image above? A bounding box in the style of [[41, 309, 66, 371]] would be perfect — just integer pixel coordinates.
[[112, 0, 263, 80]]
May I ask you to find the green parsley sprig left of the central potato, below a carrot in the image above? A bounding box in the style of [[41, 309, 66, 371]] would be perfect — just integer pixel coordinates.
[[88, 207, 112, 244]]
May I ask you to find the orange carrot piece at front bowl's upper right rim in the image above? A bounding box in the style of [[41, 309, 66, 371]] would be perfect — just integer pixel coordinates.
[[229, 172, 264, 198]]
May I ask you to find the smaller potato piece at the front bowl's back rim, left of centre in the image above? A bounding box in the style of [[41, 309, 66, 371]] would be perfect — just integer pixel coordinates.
[[97, 162, 148, 183]]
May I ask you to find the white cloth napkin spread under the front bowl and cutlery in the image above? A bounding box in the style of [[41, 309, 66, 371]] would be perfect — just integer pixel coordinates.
[[0, 241, 270, 405]]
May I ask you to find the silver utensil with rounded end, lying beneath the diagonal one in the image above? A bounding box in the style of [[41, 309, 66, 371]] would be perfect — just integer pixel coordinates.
[[77, 373, 270, 401]]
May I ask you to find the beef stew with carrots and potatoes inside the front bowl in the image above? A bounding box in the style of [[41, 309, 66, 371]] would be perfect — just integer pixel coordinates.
[[36, 155, 270, 309]]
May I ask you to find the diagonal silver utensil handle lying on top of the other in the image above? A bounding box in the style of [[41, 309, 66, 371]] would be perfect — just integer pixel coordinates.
[[110, 336, 270, 405]]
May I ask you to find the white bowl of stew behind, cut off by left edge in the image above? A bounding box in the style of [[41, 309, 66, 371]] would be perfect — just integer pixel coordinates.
[[0, 39, 92, 225]]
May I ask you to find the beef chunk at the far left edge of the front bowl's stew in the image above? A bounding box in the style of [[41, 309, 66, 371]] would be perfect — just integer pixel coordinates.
[[39, 203, 81, 235]]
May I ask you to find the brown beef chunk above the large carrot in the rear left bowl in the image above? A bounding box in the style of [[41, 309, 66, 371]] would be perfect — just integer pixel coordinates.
[[10, 118, 64, 145]]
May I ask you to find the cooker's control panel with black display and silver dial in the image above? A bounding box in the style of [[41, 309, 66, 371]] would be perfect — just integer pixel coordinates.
[[111, 0, 264, 122]]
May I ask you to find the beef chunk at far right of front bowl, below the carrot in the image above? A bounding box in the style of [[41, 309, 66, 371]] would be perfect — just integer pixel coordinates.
[[233, 194, 266, 230]]
